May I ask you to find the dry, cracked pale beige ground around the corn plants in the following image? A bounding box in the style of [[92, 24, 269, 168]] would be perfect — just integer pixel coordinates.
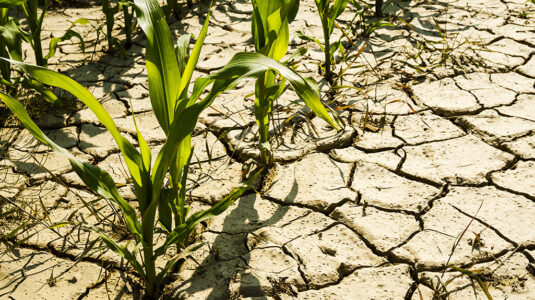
[[0, 0, 535, 300]]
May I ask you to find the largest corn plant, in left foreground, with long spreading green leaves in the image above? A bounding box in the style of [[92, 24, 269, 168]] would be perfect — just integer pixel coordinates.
[[0, 0, 255, 298]]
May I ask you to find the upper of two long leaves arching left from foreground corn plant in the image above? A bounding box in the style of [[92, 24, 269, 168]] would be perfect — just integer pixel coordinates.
[[4, 60, 148, 191]]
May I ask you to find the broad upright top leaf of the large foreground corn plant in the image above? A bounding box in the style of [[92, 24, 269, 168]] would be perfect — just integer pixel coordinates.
[[134, 0, 181, 134]]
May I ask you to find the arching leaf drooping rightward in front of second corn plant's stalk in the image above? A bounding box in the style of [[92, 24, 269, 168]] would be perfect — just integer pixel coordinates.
[[210, 52, 338, 129]]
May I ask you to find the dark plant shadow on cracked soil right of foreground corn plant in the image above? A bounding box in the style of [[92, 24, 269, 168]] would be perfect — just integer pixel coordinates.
[[168, 177, 299, 299]]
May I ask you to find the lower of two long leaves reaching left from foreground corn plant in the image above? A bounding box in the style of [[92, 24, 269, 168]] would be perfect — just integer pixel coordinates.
[[0, 93, 141, 240]]
